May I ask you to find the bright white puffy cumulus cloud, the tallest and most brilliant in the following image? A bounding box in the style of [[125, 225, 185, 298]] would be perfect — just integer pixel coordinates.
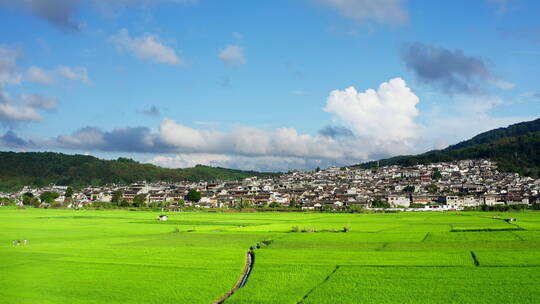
[[324, 78, 419, 145]]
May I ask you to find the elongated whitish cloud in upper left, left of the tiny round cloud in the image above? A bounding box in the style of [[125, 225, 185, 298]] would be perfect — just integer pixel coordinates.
[[109, 29, 181, 65]]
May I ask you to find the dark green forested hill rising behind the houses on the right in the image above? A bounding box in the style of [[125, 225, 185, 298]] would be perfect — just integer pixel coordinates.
[[358, 119, 540, 177]]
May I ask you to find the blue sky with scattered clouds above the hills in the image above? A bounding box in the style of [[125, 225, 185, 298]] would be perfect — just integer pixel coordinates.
[[0, 0, 540, 170]]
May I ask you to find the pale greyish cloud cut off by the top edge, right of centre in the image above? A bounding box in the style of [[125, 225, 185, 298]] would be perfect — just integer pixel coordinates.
[[313, 0, 408, 25]]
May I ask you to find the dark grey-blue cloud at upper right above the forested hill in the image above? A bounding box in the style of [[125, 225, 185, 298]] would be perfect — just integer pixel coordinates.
[[402, 42, 514, 94]]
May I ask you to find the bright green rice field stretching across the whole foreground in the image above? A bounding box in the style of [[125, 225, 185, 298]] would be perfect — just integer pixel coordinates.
[[0, 207, 540, 304]]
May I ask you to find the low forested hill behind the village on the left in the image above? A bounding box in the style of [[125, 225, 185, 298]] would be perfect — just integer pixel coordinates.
[[0, 152, 277, 191]]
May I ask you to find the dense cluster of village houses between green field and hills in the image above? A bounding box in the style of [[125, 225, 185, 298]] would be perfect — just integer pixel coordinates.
[[4, 160, 540, 210]]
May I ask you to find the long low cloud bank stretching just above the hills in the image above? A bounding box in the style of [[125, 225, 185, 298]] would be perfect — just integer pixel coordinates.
[[34, 119, 365, 159]]
